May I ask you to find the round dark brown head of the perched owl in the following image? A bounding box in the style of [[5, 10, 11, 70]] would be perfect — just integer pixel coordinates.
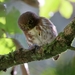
[[18, 11, 40, 31]]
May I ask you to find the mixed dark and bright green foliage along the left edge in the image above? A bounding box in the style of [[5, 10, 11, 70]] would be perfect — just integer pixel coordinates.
[[0, 4, 21, 54]]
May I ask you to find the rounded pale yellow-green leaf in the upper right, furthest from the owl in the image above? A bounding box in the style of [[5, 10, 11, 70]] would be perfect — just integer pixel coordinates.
[[59, 0, 73, 19]]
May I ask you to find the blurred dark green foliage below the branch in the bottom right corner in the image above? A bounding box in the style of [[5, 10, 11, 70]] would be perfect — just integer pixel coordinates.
[[41, 57, 75, 75]]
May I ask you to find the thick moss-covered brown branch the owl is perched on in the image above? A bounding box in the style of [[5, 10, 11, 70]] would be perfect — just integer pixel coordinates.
[[0, 18, 75, 70]]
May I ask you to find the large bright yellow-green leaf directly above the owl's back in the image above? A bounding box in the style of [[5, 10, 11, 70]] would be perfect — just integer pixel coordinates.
[[40, 0, 61, 18]]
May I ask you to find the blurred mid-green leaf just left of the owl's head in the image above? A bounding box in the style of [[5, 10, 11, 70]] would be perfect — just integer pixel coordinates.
[[5, 7, 21, 34]]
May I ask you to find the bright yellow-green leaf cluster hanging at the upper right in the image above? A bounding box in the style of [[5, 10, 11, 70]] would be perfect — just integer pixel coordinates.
[[40, 0, 75, 19]]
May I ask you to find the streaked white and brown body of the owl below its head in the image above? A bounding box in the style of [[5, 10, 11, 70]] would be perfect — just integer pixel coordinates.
[[27, 18, 57, 46]]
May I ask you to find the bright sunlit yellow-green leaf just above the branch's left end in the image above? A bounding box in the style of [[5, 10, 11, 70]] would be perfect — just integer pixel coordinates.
[[0, 38, 15, 55]]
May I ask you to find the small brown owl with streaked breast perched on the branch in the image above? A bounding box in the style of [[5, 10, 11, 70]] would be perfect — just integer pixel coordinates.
[[18, 11, 59, 59]]
